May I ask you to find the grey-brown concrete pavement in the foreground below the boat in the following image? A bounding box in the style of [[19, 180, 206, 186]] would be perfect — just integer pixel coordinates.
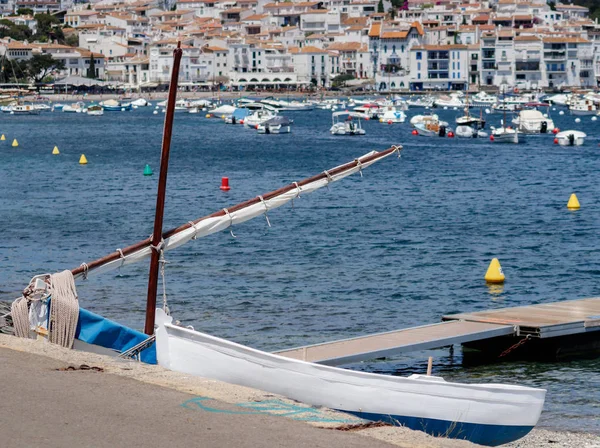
[[0, 348, 392, 448]]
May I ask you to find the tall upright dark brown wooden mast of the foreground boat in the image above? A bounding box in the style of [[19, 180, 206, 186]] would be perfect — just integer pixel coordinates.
[[144, 42, 182, 335]]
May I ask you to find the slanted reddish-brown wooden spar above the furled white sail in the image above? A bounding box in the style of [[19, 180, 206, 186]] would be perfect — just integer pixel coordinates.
[[71, 146, 402, 276]]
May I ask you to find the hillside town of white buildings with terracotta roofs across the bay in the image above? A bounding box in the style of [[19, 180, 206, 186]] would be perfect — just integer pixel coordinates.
[[0, 0, 600, 92]]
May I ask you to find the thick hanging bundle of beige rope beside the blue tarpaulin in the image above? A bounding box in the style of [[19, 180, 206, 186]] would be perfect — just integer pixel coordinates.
[[48, 270, 79, 348]]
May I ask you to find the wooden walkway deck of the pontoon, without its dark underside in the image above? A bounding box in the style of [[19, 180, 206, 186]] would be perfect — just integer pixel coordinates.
[[277, 298, 600, 365]]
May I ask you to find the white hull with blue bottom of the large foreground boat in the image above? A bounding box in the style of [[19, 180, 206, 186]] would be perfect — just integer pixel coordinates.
[[155, 309, 546, 446]]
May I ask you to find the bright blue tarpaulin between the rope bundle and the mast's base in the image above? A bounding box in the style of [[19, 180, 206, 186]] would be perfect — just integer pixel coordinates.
[[75, 308, 156, 364]]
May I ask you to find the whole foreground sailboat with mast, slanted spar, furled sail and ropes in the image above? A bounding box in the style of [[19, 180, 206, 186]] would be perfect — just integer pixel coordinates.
[[7, 45, 546, 446]]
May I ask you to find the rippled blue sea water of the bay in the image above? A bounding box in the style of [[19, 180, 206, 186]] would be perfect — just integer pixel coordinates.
[[0, 102, 600, 433]]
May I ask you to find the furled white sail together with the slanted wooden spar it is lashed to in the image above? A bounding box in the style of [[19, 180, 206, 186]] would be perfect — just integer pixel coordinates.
[[72, 146, 402, 278]]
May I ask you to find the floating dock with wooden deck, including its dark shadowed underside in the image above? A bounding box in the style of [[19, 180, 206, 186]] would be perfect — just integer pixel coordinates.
[[276, 297, 600, 366]]
